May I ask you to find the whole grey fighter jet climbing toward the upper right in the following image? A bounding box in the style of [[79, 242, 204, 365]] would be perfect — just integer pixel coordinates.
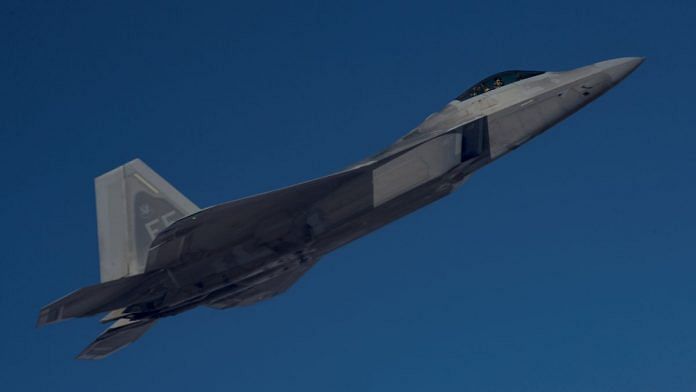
[[38, 57, 643, 359]]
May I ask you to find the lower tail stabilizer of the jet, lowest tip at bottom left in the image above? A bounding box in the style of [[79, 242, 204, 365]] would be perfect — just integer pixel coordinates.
[[77, 319, 156, 360]]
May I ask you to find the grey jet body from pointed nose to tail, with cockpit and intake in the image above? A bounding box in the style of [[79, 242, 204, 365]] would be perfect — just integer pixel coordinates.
[[126, 58, 642, 318]]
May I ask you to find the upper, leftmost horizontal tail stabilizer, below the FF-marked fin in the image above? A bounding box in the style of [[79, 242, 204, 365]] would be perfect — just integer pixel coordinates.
[[36, 275, 150, 327]]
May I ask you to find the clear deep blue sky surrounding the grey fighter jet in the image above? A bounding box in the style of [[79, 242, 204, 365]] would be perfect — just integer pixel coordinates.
[[0, 0, 696, 392]]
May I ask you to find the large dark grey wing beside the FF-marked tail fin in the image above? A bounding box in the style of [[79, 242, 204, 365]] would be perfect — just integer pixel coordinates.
[[147, 163, 372, 270]]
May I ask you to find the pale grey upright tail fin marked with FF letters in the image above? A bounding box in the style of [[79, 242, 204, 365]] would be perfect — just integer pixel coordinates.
[[94, 159, 199, 282]]
